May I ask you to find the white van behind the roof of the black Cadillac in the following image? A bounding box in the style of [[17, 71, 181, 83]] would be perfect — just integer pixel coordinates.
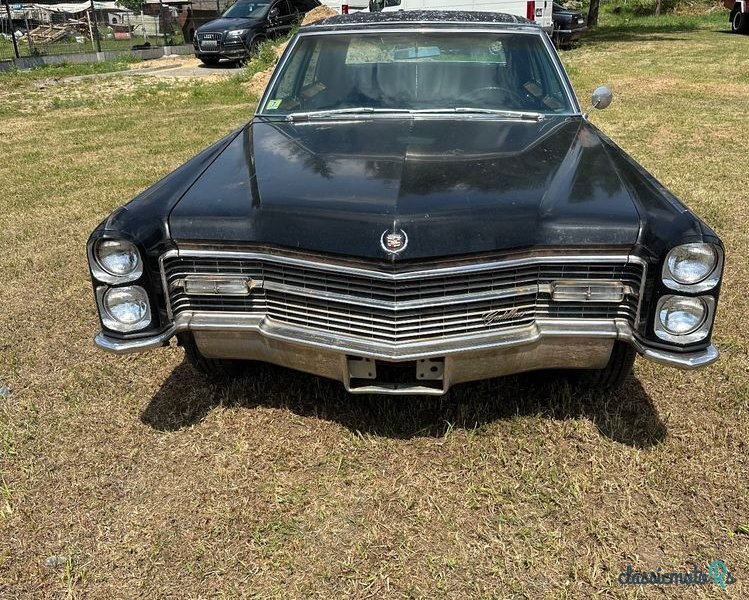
[[366, 0, 554, 32]]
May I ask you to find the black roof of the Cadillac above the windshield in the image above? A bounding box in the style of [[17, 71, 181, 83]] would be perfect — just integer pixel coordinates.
[[300, 10, 541, 32]]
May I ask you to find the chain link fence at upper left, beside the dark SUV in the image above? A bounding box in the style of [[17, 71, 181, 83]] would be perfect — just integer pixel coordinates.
[[0, 0, 217, 61]]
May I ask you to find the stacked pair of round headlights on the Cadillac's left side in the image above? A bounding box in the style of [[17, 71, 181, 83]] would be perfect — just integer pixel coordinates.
[[89, 239, 151, 333]]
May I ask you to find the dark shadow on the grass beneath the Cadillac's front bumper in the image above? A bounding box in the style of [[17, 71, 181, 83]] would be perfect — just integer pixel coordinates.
[[141, 363, 666, 448]]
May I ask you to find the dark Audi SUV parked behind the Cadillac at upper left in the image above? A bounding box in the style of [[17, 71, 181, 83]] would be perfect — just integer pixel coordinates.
[[193, 0, 320, 65]]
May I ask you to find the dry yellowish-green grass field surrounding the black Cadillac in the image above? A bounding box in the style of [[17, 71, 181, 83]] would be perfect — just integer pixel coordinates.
[[0, 14, 749, 599]]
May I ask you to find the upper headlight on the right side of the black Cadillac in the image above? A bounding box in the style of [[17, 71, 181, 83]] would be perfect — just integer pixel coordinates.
[[663, 243, 721, 291]]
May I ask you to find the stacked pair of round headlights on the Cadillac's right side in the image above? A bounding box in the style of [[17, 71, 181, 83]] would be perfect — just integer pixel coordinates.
[[655, 243, 723, 344]]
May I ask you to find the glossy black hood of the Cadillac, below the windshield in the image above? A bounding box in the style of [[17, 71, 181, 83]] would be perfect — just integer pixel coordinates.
[[169, 117, 640, 260]]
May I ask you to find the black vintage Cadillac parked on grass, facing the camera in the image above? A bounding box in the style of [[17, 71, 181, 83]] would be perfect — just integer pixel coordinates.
[[88, 12, 723, 394]]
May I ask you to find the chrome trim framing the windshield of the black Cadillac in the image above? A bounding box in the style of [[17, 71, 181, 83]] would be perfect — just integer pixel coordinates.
[[255, 26, 583, 118]]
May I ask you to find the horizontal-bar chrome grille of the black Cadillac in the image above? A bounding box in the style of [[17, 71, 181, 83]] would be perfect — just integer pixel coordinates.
[[163, 256, 643, 343]]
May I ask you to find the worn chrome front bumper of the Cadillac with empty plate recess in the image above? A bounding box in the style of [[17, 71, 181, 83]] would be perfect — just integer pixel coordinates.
[[95, 312, 719, 394]]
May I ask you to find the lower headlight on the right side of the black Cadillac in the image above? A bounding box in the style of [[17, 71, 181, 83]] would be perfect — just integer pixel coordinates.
[[655, 296, 715, 344]]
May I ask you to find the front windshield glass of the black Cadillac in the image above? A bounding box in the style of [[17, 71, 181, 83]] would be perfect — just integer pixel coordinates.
[[261, 31, 572, 115]]
